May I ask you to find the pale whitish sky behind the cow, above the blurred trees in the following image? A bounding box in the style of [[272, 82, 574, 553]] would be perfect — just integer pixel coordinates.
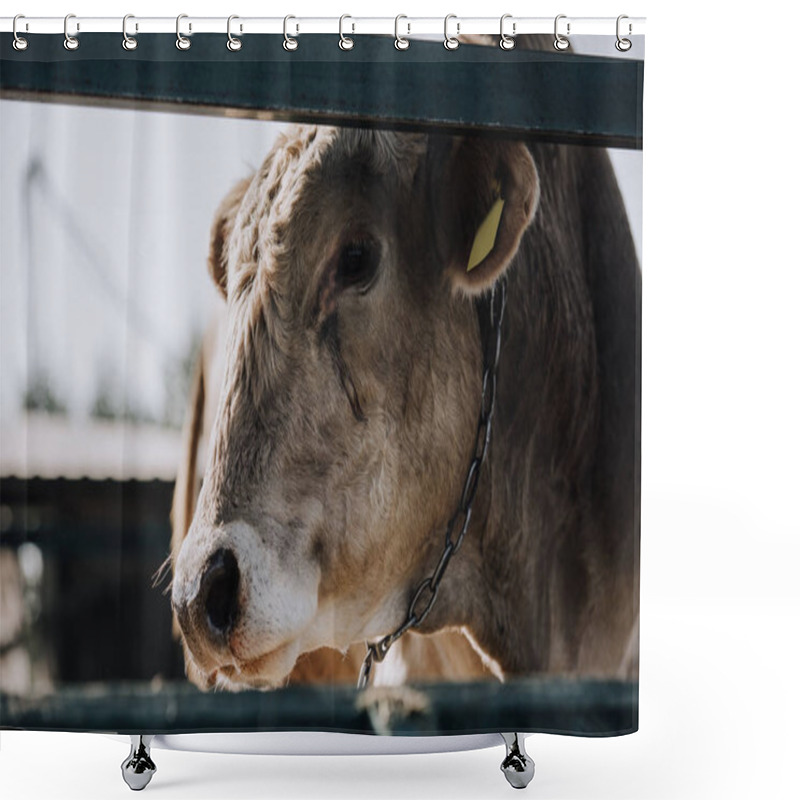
[[0, 101, 642, 424]]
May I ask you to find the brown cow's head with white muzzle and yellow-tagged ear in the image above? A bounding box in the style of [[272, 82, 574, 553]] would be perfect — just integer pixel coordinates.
[[172, 127, 538, 688]]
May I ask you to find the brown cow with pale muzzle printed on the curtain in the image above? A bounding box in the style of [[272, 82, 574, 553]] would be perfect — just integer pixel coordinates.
[[172, 126, 640, 687]]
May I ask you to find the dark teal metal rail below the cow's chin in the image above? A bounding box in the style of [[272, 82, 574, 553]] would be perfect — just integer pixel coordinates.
[[0, 679, 638, 736]]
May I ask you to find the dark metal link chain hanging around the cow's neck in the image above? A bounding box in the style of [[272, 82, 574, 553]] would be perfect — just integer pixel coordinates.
[[357, 278, 506, 689]]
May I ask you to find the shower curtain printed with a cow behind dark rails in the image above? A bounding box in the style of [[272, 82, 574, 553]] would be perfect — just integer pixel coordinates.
[[0, 23, 644, 752]]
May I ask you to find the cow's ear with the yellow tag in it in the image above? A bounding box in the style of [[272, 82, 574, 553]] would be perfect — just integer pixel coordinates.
[[433, 137, 539, 294]]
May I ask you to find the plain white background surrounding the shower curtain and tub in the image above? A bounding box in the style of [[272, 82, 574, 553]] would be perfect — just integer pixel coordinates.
[[0, 0, 800, 800]]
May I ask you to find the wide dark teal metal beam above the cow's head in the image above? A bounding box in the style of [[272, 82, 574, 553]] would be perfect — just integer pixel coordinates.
[[0, 34, 644, 148]]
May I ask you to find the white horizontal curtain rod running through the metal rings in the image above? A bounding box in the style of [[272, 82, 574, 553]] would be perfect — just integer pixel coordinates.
[[0, 15, 645, 37]]
